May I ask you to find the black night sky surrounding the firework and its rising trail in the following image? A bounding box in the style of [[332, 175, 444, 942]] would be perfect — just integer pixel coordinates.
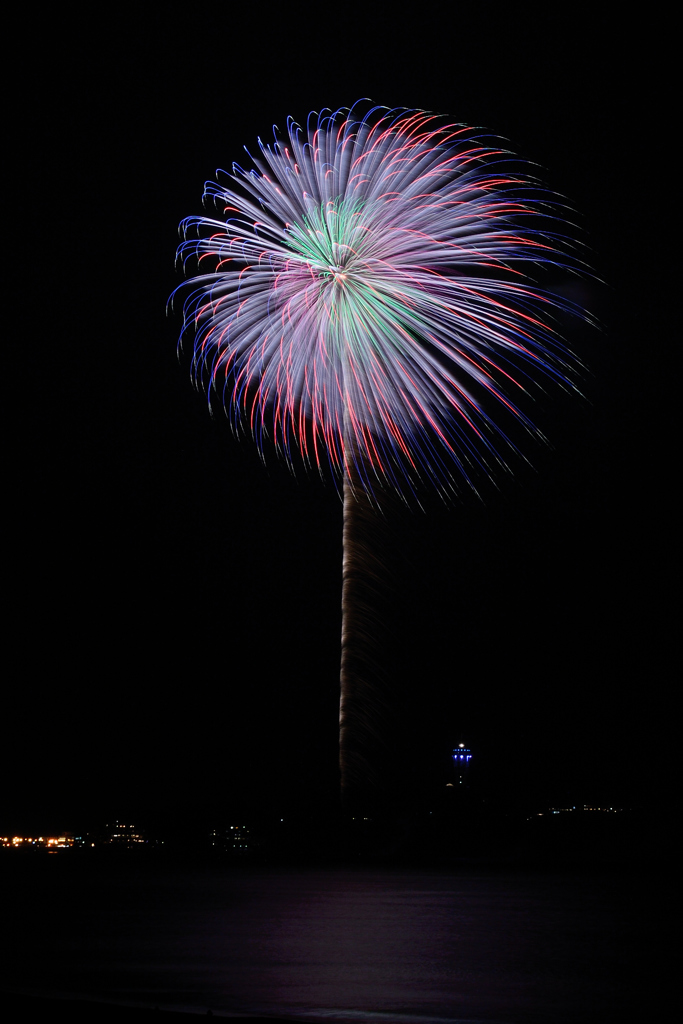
[[3, 12, 673, 827]]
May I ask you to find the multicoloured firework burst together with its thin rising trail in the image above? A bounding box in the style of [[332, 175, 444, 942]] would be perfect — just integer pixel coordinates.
[[171, 104, 589, 788]]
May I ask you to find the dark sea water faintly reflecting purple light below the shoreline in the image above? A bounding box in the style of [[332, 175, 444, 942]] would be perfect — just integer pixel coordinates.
[[0, 856, 673, 1024]]
